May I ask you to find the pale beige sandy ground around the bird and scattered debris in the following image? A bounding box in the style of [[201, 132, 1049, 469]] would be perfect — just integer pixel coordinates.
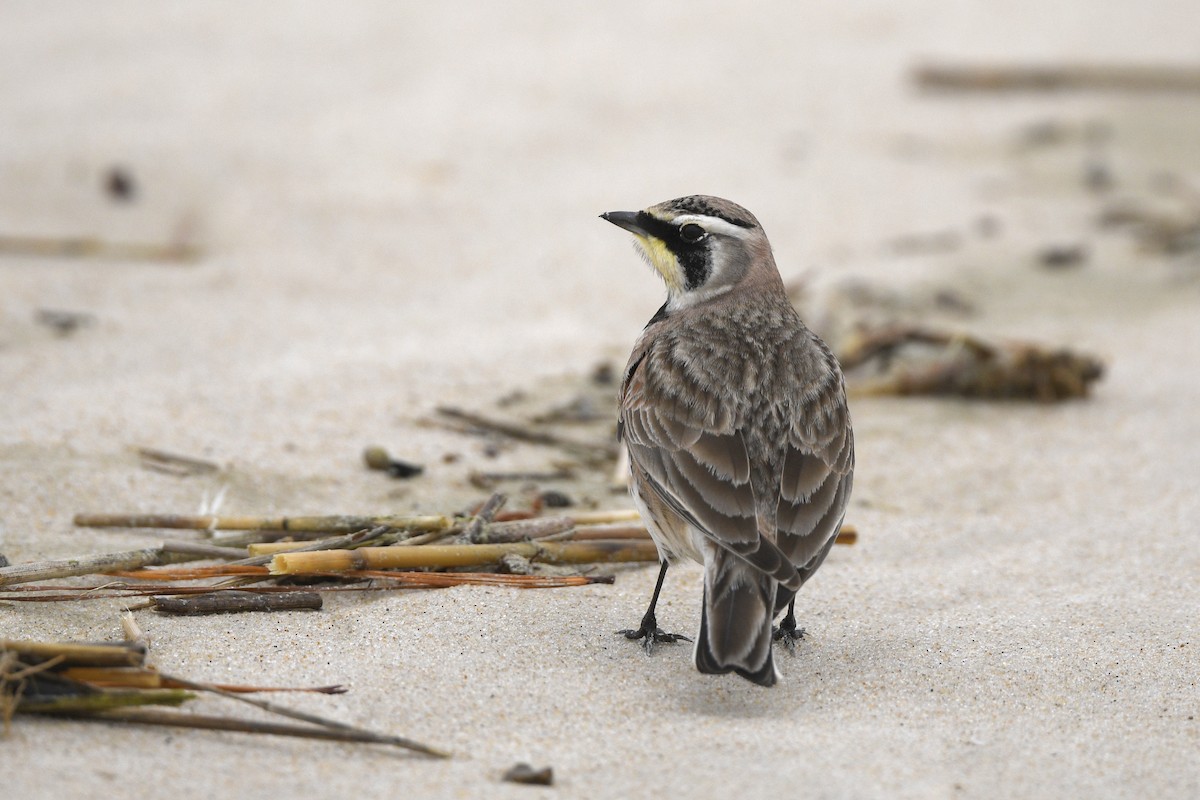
[[0, 0, 1200, 799]]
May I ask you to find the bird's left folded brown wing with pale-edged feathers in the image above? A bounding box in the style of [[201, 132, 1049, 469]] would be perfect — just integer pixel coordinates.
[[620, 352, 800, 590]]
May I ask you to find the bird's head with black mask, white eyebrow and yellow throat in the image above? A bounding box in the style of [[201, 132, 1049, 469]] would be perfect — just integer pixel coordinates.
[[600, 194, 779, 311]]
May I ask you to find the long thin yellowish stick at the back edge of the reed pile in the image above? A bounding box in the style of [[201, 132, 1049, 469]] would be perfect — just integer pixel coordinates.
[[74, 513, 451, 534]]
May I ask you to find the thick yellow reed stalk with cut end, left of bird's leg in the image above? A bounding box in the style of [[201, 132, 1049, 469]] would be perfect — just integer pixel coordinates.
[[271, 541, 658, 575]]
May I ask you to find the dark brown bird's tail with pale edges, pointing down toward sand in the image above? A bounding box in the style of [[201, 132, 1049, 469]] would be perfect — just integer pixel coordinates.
[[695, 548, 779, 686]]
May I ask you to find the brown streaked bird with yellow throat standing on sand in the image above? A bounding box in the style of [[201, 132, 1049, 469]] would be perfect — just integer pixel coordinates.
[[600, 194, 854, 686]]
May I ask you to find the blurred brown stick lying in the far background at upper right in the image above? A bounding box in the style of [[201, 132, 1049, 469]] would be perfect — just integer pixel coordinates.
[[913, 64, 1200, 92]]
